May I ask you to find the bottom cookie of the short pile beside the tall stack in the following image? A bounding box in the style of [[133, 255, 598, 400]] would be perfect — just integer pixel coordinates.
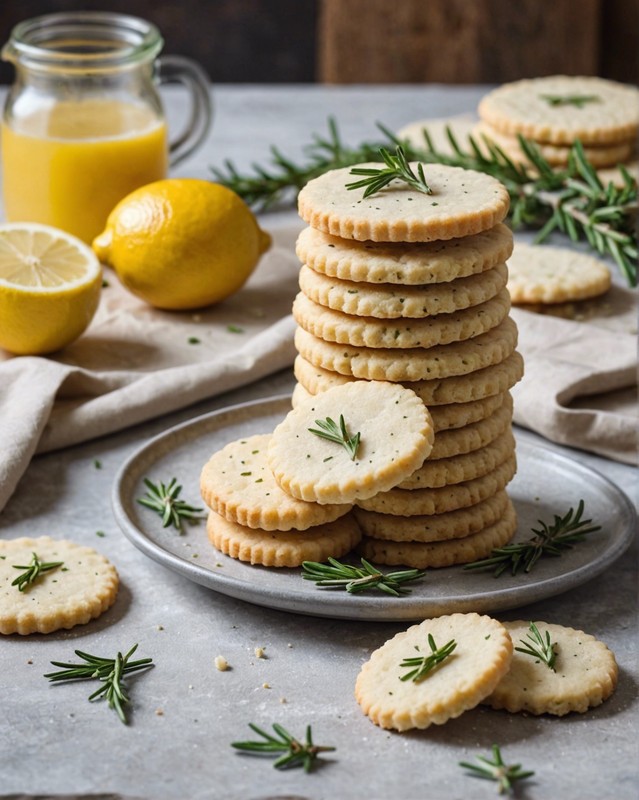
[[206, 511, 361, 567]]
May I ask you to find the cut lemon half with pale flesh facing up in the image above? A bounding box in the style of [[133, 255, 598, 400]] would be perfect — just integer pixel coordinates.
[[0, 222, 102, 355]]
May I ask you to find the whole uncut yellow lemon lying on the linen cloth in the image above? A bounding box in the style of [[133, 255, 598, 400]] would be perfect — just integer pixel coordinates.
[[93, 178, 271, 309]]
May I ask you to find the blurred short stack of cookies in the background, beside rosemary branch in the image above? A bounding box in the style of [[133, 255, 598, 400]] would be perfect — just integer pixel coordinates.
[[475, 75, 639, 168]]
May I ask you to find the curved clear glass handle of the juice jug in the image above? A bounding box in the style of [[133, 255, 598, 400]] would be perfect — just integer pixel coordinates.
[[156, 55, 213, 167]]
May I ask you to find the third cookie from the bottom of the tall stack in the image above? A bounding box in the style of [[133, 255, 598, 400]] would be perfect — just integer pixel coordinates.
[[357, 453, 517, 517]]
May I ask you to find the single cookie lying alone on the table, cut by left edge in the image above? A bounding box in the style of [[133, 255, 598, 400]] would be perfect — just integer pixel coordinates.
[[0, 536, 119, 635]]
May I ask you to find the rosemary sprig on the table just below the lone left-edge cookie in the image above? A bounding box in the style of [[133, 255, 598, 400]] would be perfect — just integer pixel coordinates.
[[44, 644, 154, 725]]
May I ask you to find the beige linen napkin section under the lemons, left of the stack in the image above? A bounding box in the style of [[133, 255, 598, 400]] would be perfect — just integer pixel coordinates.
[[0, 215, 302, 509]]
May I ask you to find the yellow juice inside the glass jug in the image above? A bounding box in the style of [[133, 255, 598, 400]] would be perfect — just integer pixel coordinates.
[[2, 100, 168, 243]]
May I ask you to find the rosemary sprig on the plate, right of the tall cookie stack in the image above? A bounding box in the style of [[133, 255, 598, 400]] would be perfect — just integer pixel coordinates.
[[463, 500, 601, 578]]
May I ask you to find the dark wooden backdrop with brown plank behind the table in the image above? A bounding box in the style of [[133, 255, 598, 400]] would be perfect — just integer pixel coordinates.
[[0, 0, 639, 83]]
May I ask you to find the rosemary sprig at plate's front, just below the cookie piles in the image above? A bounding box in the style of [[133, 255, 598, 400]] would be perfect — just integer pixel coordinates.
[[302, 556, 426, 597]]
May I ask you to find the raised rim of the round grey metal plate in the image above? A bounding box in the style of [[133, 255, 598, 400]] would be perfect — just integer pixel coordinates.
[[111, 393, 637, 622]]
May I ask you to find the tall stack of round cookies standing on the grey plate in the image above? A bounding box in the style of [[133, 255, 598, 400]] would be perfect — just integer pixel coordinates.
[[293, 164, 523, 569]]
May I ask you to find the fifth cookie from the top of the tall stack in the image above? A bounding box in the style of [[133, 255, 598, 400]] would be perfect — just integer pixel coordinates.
[[295, 317, 517, 382]]
